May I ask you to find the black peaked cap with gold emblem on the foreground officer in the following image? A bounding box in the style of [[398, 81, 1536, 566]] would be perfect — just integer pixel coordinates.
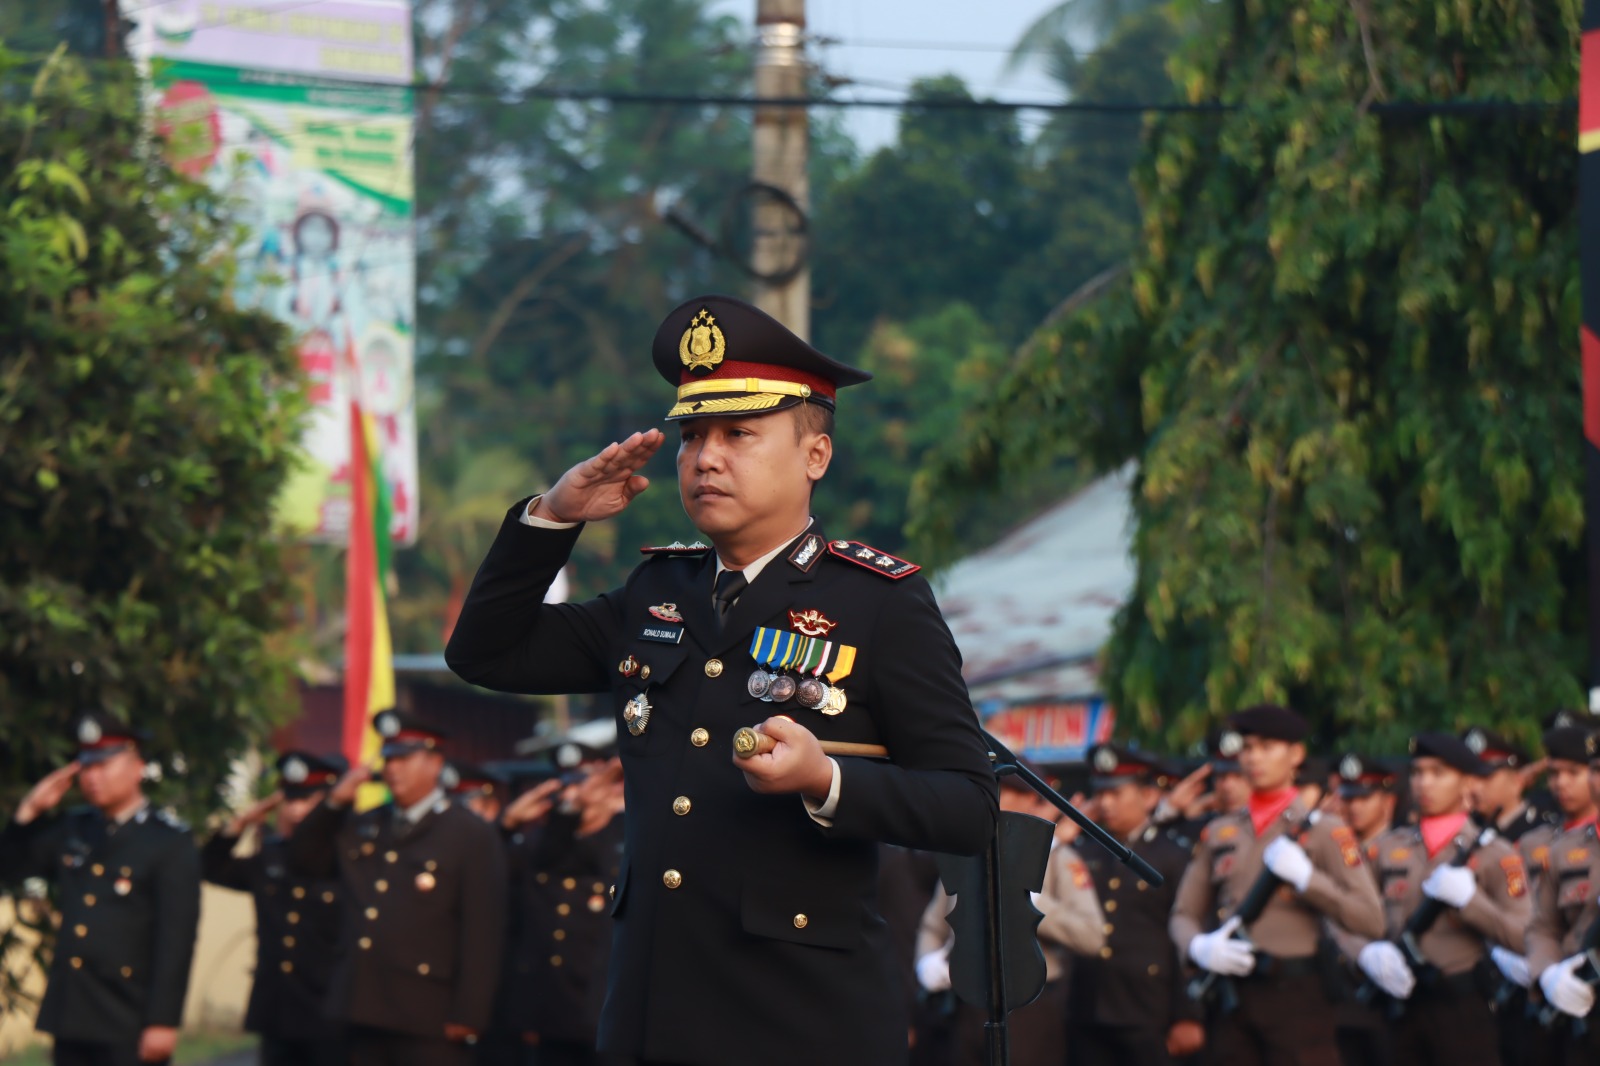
[[650, 296, 872, 421]]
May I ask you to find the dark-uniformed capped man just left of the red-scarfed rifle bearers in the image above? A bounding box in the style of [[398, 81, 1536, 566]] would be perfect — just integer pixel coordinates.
[[1067, 744, 1205, 1066]]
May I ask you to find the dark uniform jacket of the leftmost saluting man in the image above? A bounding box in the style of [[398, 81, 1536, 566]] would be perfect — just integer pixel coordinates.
[[0, 805, 200, 1044]]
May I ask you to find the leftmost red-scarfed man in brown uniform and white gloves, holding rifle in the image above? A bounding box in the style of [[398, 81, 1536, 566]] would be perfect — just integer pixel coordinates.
[[1168, 704, 1384, 1066]]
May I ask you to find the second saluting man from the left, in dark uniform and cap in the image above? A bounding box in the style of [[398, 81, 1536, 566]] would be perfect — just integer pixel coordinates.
[[200, 751, 349, 1066]]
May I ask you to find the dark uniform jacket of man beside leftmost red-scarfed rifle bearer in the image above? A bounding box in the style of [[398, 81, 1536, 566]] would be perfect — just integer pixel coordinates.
[[1067, 826, 1202, 1036]]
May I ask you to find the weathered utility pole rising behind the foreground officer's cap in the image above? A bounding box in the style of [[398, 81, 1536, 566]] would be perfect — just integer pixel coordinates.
[[750, 0, 811, 339]]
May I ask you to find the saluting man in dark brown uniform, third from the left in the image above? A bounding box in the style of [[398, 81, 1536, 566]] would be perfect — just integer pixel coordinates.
[[288, 711, 506, 1066]]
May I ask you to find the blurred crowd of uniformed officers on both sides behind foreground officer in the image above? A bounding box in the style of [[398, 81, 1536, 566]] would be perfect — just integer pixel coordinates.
[[0, 706, 1600, 1066]]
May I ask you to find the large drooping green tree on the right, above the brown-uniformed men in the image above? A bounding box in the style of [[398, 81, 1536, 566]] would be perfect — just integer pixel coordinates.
[[920, 0, 1586, 746]]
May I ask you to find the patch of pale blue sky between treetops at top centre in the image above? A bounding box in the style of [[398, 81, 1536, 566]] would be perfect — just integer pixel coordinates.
[[712, 0, 1061, 152]]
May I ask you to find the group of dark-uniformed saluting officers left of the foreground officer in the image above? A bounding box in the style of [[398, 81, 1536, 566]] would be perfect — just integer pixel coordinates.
[[0, 711, 622, 1066]]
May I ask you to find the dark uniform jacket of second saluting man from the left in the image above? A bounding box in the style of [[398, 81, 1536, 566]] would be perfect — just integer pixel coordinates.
[[200, 832, 341, 1040]]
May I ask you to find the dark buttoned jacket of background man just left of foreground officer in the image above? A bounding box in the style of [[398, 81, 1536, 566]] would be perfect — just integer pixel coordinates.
[[504, 813, 624, 1045]]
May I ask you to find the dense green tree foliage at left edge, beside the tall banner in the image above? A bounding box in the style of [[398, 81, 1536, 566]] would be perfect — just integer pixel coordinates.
[[0, 50, 304, 813]]
